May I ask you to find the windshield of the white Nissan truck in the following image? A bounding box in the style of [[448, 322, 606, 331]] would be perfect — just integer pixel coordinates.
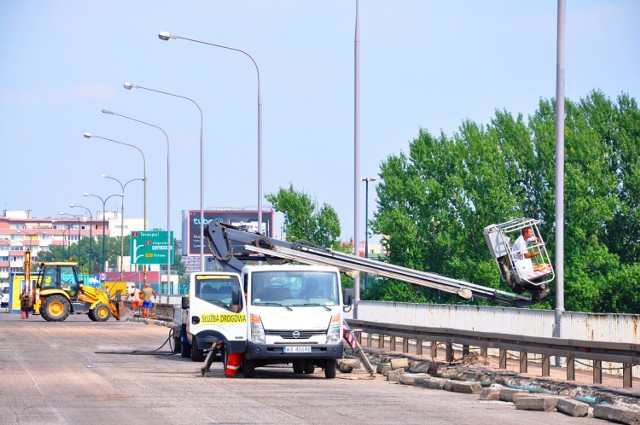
[[251, 270, 340, 307]]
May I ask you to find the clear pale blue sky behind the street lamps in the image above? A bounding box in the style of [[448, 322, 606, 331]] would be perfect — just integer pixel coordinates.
[[0, 0, 640, 240]]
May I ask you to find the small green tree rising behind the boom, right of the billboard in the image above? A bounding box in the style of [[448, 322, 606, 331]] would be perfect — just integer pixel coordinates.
[[266, 184, 340, 249]]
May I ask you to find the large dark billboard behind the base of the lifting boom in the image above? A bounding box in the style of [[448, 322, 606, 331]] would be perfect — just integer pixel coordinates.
[[182, 209, 273, 255]]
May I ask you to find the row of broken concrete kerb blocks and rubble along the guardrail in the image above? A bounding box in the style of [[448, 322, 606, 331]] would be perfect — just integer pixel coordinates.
[[344, 346, 640, 425]]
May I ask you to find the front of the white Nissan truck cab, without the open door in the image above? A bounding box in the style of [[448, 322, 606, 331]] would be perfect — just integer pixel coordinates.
[[242, 265, 343, 378]]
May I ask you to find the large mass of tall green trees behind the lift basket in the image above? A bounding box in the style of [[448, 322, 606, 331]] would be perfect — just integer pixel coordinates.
[[371, 91, 640, 313]]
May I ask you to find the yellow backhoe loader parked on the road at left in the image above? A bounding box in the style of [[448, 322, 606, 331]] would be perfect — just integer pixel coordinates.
[[35, 262, 123, 322]]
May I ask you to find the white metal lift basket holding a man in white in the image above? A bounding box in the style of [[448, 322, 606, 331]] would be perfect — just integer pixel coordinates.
[[484, 218, 555, 301]]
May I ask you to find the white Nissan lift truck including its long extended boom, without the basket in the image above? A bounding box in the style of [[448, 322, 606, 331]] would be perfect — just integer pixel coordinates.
[[174, 222, 548, 378]]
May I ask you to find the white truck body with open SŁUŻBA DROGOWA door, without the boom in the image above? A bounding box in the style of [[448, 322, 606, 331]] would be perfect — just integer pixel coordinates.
[[180, 264, 343, 378]]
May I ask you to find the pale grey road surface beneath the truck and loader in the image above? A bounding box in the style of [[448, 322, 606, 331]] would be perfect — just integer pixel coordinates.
[[0, 312, 606, 425]]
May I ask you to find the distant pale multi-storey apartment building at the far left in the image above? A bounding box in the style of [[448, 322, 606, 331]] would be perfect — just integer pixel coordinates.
[[0, 210, 144, 282]]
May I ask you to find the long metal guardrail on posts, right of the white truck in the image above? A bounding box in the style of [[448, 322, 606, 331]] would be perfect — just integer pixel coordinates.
[[347, 319, 640, 388]]
